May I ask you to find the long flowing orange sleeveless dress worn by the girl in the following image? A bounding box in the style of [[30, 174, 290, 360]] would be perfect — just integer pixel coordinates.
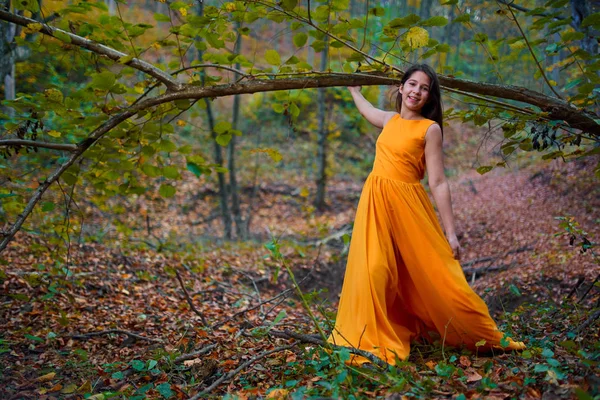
[[329, 114, 525, 364]]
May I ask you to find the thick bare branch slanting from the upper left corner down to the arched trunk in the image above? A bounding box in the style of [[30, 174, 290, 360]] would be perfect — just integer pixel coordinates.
[[0, 10, 183, 91]]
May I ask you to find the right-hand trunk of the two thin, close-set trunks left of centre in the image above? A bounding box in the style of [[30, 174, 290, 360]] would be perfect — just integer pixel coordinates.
[[227, 22, 244, 238]]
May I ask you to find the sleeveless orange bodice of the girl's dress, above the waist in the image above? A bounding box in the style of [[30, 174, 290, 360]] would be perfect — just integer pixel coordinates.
[[372, 114, 435, 183]]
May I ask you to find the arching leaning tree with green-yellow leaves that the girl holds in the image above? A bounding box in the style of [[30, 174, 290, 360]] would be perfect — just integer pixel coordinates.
[[0, 0, 600, 255]]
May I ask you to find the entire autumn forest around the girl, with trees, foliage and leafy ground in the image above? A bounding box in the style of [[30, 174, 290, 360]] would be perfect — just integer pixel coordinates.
[[0, 0, 600, 400]]
